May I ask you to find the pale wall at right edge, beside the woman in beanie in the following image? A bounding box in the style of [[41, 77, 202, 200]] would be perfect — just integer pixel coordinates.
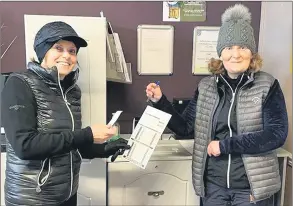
[[259, 2, 292, 206]]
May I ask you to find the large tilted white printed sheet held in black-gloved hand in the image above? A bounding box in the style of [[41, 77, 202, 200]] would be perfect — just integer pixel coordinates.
[[123, 106, 171, 169]]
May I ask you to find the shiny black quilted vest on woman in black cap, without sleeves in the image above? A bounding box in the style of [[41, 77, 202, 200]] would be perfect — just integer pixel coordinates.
[[5, 62, 81, 206]]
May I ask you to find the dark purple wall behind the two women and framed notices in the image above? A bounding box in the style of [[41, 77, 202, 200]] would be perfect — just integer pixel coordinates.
[[0, 1, 261, 132]]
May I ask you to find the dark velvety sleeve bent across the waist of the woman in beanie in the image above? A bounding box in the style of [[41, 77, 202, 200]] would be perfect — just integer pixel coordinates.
[[220, 80, 288, 154]]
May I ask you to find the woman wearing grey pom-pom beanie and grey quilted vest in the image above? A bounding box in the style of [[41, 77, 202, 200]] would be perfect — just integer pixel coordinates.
[[146, 4, 288, 206]]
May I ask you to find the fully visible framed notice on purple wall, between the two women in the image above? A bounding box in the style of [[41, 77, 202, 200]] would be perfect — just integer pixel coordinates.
[[137, 25, 174, 75]]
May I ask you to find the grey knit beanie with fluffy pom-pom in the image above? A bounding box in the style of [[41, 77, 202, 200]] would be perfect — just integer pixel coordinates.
[[217, 4, 256, 56]]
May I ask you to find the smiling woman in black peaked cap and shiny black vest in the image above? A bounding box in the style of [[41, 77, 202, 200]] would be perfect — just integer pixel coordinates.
[[1, 22, 129, 206]]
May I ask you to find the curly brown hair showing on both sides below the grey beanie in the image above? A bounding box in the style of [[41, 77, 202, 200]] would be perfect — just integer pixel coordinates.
[[208, 53, 263, 74]]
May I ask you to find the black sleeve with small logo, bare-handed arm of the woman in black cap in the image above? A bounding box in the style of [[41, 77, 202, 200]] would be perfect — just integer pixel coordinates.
[[1, 76, 93, 160]]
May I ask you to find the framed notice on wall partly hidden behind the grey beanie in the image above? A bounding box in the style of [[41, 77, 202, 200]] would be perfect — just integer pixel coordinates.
[[192, 26, 220, 75]]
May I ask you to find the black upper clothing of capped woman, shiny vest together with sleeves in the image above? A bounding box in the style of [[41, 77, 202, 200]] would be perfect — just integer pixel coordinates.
[[1, 63, 105, 206]]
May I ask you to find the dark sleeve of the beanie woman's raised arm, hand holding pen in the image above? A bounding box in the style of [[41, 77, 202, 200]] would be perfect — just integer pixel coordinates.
[[153, 90, 198, 137]]
